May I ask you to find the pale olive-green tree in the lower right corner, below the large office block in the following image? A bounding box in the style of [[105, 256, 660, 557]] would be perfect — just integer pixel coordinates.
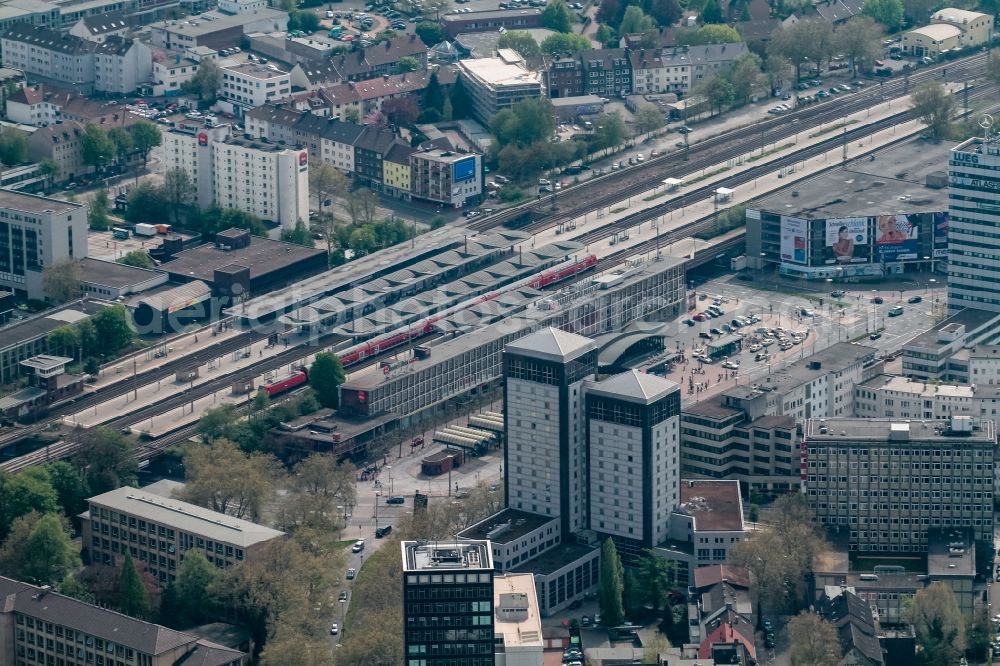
[[908, 581, 965, 666]]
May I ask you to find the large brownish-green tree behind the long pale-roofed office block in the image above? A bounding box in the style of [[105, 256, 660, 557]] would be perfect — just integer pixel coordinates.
[[183, 439, 281, 520]]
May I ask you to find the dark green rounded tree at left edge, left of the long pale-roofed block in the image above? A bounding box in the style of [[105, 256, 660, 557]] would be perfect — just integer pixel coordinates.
[[0, 511, 80, 585]]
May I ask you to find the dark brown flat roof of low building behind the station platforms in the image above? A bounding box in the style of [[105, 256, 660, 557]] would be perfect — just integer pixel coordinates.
[[160, 236, 325, 286]]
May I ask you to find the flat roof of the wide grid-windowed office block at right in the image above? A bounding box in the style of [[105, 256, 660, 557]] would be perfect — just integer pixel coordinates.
[[803, 416, 996, 445]]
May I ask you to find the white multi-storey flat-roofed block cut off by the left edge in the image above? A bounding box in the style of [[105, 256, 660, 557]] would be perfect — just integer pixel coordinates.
[[0, 190, 87, 300]]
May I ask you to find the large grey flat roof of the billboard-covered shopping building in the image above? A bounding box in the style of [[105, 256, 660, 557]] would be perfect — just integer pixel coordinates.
[[752, 139, 953, 219]]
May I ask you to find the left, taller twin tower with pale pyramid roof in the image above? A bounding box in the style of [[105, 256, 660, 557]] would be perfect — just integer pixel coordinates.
[[504, 328, 597, 539]]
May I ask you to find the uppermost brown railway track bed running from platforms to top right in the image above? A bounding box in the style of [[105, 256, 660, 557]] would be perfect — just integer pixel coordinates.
[[469, 54, 986, 232]]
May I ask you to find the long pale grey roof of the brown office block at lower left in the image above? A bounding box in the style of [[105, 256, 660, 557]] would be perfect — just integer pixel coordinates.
[[87, 486, 285, 548]]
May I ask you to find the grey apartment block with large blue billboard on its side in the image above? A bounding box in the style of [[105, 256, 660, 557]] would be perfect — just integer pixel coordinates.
[[410, 148, 483, 208]]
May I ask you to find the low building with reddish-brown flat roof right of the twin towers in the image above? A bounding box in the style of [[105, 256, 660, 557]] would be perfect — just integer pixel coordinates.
[[653, 479, 747, 585]]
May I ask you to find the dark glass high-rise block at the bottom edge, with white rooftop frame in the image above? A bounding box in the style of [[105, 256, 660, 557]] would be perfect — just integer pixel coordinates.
[[400, 541, 492, 666]]
